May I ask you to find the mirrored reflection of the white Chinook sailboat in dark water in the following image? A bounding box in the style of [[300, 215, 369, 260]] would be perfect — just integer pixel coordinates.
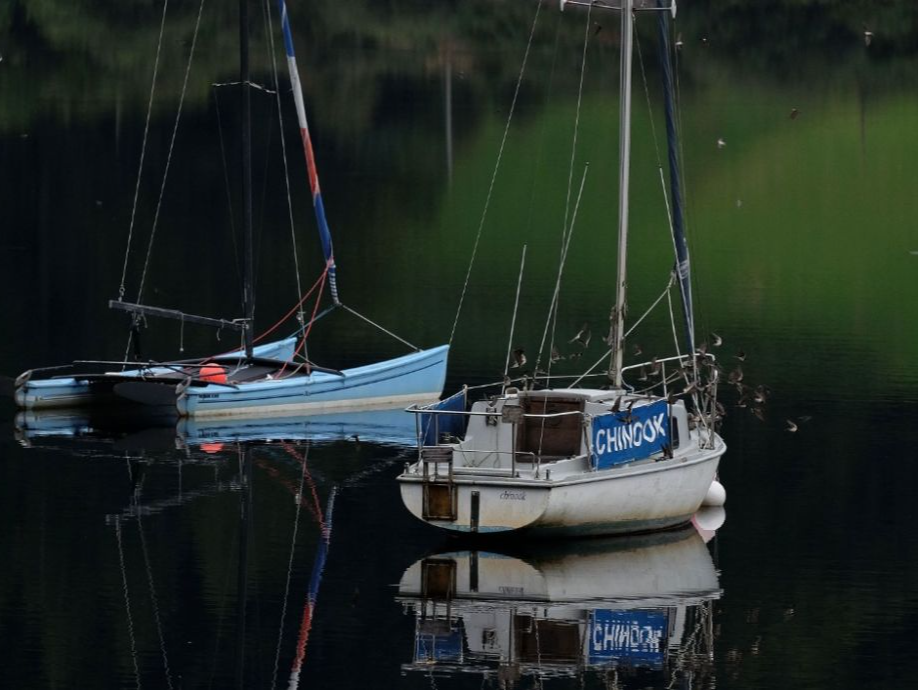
[[398, 528, 721, 681]]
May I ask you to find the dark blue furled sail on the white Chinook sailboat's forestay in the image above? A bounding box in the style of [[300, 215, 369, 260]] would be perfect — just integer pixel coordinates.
[[657, 0, 695, 353]]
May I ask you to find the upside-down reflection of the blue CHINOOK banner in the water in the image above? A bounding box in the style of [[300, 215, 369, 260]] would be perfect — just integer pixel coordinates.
[[589, 609, 667, 668]]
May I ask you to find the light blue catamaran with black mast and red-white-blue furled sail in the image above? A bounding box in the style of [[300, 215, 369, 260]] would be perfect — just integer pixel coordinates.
[[14, 0, 448, 417]]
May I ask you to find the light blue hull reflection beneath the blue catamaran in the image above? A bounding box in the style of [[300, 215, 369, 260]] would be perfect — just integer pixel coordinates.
[[14, 400, 417, 449]]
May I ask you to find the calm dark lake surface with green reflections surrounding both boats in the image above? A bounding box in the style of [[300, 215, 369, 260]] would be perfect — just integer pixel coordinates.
[[0, 0, 918, 689]]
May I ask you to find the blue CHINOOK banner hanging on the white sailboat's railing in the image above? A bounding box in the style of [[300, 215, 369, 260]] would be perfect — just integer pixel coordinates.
[[593, 400, 670, 470]]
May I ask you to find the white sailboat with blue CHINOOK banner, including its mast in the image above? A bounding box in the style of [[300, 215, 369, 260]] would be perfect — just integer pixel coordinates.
[[398, 0, 726, 535]]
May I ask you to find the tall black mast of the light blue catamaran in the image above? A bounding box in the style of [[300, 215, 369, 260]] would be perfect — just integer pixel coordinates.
[[239, 0, 255, 357]]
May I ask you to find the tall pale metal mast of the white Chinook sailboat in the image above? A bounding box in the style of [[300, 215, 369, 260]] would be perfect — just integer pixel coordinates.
[[611, 0, 634, 387]]
